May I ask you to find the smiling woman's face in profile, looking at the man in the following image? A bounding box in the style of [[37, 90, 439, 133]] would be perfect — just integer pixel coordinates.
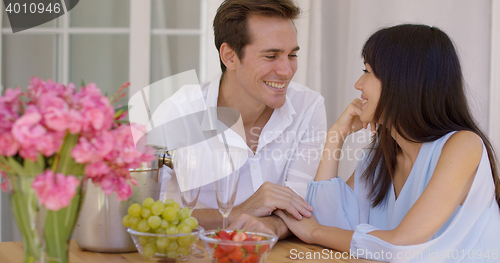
[[354, 63, 382, 123]]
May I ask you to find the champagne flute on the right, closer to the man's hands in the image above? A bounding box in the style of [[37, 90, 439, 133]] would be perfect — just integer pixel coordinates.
[[212, 145, 247, 229]]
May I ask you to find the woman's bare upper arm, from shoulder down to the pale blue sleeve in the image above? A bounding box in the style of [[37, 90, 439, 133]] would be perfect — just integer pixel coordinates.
[[370, 131, 483, 245]]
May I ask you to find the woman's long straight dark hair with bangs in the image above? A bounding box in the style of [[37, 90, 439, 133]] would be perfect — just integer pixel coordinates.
[[362, 24, 500, 207]]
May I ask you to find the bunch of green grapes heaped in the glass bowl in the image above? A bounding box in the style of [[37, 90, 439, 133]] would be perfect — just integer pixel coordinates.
[[122, 198, 198, 258]]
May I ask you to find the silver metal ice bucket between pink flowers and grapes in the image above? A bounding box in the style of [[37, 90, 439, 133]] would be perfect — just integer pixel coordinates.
[[75, 146, 171, 253]]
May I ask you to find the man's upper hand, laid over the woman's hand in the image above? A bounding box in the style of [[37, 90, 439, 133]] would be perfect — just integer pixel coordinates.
[[230, 182, 313, 222]]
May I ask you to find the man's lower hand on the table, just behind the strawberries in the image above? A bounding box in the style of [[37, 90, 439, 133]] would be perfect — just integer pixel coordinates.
[[228, 214, 290, 239]]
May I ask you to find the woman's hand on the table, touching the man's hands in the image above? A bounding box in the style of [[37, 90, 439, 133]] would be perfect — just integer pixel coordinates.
[[274, 210, 321, 244]]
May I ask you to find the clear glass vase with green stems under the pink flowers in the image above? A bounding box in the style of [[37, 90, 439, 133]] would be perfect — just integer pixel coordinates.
[[8, 175, 85, 263]]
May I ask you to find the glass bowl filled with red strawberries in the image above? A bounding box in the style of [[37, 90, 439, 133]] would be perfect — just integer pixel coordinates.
[[200, 229, 278, 263]]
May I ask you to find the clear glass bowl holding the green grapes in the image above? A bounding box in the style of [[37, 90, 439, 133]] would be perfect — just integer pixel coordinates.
[[127, 226, 204, 261]]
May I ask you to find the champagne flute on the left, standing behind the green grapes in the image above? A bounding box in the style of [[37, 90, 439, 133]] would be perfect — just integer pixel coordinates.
[[172, 146, 206, 212]]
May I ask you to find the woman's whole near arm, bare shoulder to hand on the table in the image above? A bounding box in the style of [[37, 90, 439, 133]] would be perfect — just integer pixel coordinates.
[[275, 131, 482, 251]]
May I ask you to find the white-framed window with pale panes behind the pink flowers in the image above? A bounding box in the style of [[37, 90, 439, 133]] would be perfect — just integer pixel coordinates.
[[0, 0, 207, 241]]
